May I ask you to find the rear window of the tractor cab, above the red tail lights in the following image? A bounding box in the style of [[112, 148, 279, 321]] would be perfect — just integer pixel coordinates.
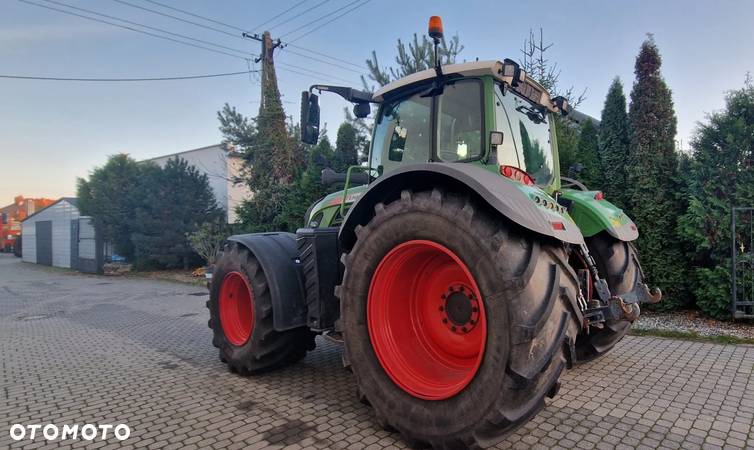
[[497, 84, 554, 186]]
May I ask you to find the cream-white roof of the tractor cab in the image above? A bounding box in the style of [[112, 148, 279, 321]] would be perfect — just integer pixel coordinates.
[[372, 60, 558, 112]]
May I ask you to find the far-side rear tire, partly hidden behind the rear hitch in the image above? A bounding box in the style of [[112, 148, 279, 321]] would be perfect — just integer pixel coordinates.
[[576, 233, 643, 363]]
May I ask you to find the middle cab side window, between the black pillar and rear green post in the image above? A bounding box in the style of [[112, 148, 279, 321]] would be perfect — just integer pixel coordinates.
[[437, 80, 484, 162]]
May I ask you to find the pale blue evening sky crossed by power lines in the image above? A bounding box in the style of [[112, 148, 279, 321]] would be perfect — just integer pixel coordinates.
[[0, 0, 754, 201]]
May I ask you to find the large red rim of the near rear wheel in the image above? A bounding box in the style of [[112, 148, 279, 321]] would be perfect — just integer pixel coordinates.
[[367, 240, 487, 400]]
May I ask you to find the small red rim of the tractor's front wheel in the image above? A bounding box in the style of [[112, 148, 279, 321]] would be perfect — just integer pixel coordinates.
[[220, 272, 254, 346]]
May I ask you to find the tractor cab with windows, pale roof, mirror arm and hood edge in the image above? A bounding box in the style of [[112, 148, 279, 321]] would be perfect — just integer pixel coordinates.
[[301, 59, 568, 227]]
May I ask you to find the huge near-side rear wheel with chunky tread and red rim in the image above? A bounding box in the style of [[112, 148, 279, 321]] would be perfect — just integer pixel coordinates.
[[336, 190, 579, 448]]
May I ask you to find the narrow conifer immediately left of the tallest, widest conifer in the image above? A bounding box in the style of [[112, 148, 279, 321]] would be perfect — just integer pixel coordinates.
[[599, 77, 629, 208]]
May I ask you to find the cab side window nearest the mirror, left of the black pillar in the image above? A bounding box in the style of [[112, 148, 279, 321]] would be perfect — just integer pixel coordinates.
[[371, 94, 432, 172]]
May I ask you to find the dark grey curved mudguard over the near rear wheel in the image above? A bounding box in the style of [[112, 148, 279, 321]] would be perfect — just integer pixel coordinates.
[[340, 163, 584, 250]]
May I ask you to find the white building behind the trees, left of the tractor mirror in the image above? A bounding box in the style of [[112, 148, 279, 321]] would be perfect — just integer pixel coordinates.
[[147, 144, 251, 223]]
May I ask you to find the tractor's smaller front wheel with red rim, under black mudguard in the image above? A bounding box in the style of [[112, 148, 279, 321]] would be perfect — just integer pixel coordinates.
[[207, 242, 315, 375]]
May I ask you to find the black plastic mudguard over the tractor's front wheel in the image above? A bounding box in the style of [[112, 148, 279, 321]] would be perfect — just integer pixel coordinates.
[[228, 233, 306, 331]]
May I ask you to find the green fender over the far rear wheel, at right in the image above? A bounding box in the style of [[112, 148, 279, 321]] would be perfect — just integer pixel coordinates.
[[560, 189, 639, 241]]
